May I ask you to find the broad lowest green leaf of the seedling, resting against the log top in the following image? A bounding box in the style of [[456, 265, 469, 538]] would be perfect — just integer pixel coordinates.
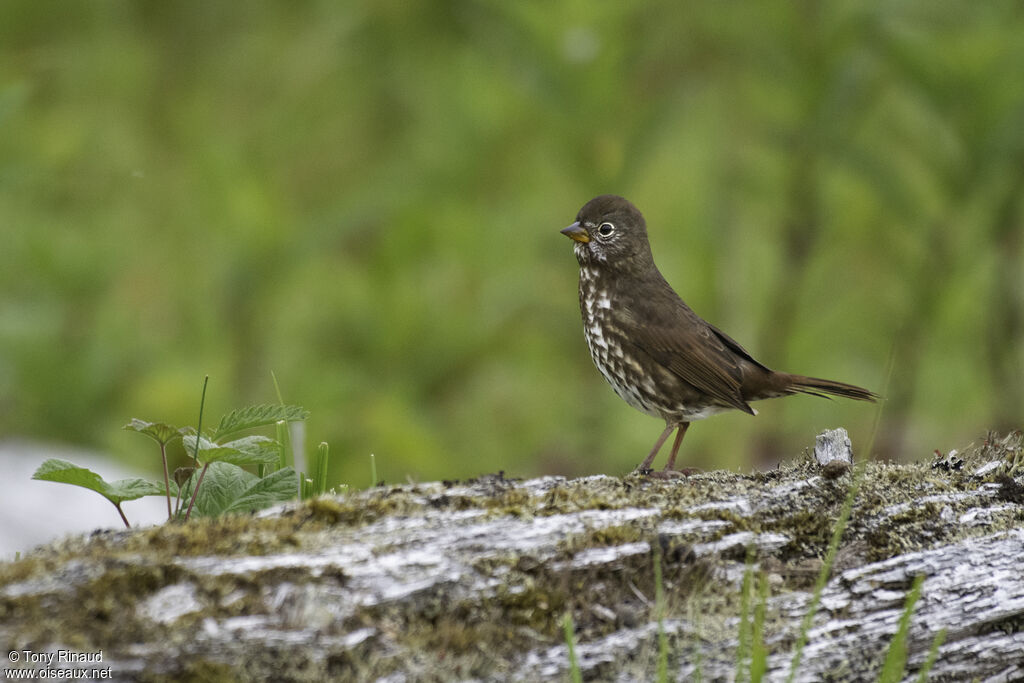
[[185, 462, 298, 517]]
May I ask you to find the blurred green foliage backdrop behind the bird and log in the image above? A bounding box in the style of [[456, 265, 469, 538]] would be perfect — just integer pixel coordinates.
[[0, 0, 1024, 486]]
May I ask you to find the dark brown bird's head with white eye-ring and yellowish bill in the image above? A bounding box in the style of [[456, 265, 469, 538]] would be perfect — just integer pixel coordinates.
[[562, 195, 653, 268]]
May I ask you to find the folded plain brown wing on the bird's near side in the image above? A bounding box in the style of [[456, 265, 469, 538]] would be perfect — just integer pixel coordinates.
[[620, 284, 761, 415]]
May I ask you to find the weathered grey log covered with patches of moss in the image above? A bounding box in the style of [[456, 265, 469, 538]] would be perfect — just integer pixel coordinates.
[[0, 433, 1024, 681]]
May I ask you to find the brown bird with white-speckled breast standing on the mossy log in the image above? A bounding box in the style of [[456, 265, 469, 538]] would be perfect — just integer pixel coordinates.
[[562, 195, 879, 474]]
